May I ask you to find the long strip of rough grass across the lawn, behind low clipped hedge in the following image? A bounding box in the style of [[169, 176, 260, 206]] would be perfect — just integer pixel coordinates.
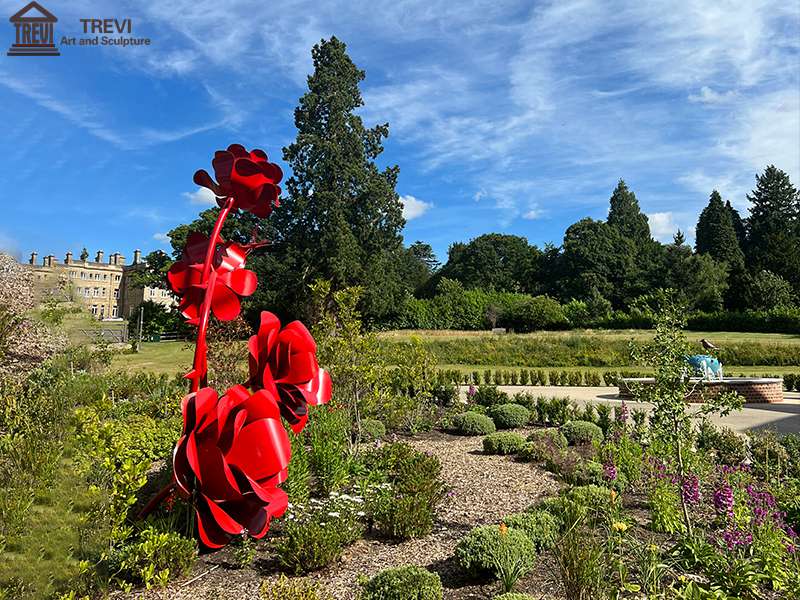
[[381, 333, 800, 368]]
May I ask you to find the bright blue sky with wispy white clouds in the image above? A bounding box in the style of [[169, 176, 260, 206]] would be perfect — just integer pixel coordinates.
[[0, 0, 800, 260]]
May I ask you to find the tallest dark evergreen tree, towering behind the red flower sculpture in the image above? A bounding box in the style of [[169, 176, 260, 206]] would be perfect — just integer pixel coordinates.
[[271, 37, 405, 319]]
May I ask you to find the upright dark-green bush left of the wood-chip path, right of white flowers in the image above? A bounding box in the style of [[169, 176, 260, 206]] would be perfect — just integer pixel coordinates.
[[365, 444, 445, 540]]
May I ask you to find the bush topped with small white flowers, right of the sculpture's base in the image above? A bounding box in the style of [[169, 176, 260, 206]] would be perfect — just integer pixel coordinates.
[[274, 495, 364, 575]]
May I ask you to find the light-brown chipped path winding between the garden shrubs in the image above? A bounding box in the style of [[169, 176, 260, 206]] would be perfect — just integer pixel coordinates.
[[127, 431, 559, 600]]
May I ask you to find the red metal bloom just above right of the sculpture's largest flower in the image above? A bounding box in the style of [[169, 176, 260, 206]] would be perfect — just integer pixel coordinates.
[[248, 311, 331, 433]]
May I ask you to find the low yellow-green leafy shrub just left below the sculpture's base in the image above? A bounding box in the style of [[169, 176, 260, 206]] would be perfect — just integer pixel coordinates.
[[109, 526, 197, 588]]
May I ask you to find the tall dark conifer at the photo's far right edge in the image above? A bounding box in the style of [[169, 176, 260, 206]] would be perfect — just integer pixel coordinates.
[[747, 165, 800, 293]]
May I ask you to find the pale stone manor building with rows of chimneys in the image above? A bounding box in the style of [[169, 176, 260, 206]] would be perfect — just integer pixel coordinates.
[[28, 250, 176, 320]]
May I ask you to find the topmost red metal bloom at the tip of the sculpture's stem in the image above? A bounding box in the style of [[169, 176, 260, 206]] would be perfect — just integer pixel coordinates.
[[194, 144, 283, 218]]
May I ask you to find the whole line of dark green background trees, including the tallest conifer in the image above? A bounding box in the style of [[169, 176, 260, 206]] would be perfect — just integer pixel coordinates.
[[141, 37, 800, 326]]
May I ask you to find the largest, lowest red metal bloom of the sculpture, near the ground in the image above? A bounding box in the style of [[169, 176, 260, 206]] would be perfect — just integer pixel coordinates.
[[173, 385, 291, 548]]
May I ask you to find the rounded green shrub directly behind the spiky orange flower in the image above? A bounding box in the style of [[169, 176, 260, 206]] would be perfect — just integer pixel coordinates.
[[456, 525, 536, 577]]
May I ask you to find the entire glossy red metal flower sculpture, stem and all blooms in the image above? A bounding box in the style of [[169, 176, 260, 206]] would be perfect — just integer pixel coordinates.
[[139, 144, 331, 548]]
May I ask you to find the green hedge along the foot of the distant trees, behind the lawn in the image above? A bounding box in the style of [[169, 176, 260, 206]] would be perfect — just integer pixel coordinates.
[[389, 289, 800, 333]]
